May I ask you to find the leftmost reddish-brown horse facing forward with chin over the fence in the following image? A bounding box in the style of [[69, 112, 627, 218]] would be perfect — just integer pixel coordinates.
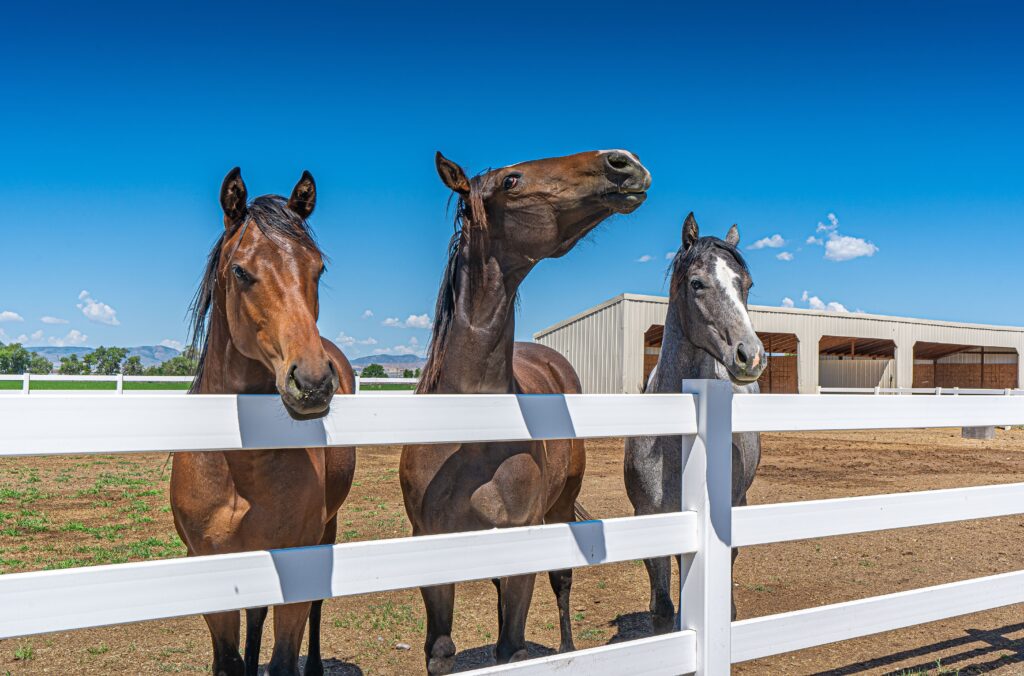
[[169, 168, 355, 676]]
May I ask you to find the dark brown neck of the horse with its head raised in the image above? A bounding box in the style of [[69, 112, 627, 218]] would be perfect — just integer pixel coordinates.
[[428, 247, 526, 394]]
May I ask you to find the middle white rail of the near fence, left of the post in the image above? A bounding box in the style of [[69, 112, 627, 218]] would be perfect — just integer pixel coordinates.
[[0, 512, 696, 638]]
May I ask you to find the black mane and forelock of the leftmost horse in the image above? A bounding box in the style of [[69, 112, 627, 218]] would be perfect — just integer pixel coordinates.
[[188, 195, 324, 392]]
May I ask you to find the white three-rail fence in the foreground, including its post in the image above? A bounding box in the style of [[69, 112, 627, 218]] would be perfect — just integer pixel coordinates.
[[0, 381, 1024, 676]]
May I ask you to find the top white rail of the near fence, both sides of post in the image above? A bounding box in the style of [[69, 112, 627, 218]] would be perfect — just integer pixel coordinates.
[[0, 393, 1024, 456]]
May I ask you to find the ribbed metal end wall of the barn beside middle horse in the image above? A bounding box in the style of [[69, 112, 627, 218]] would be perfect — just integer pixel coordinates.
[[534, 297, 622, 394]]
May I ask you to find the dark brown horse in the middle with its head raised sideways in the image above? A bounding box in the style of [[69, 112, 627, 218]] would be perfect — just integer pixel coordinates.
[[399, 151, 650, 674]]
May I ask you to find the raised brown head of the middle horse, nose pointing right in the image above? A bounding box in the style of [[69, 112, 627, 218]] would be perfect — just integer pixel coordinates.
[[436, 151, 650, 262]]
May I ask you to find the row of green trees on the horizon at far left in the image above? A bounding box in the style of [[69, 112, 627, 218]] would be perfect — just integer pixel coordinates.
[[0, 343, 199, 376]]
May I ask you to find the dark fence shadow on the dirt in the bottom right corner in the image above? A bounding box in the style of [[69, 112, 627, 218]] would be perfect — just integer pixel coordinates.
[[814, 623, 1024, 676]]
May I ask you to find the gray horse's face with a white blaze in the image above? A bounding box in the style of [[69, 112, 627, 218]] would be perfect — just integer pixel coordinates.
[[672, 214, 767, 385]]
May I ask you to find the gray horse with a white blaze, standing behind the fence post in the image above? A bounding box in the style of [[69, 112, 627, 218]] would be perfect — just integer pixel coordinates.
[[625, 213, 765, 634]]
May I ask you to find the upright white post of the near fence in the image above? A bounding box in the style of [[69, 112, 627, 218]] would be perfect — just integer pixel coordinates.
[[679, 380, 732, 676]]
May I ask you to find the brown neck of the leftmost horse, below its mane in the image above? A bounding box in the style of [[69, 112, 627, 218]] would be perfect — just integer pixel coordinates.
[[197, 309, 278, 394]]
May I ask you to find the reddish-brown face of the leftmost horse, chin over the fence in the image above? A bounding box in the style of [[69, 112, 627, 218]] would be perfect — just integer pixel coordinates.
[[217, 169, 338, 420]]
